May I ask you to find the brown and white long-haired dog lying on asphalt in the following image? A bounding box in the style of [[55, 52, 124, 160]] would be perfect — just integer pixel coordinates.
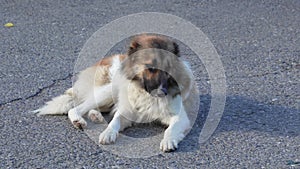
[[34, 34, 192, 152]]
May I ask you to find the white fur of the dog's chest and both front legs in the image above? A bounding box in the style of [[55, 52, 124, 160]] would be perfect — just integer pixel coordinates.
[[99, 70, 190, 152]]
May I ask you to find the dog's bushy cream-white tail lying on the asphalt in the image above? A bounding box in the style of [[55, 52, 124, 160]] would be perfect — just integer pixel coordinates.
[[32, 88, 74, 116]]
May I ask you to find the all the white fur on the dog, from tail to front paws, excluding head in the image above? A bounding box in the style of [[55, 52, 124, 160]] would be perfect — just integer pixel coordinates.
[[35, 55, 191, 152]]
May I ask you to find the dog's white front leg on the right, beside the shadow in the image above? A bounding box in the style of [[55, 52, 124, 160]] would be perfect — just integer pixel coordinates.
[[160, 96, 190, 152]]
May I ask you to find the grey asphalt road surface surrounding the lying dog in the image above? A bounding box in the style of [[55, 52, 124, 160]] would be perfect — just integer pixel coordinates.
[[0, 0, 300, 168]]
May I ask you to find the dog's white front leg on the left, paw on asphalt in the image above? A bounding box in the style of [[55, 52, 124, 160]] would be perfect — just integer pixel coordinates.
[[99, 111, 132, 144]]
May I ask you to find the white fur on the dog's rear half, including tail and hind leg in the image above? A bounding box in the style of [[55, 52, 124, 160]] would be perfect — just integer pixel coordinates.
[[33, 55, 121, 125]]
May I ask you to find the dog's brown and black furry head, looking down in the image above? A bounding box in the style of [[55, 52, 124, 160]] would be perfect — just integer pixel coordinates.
[[122, 35, 180, 97]]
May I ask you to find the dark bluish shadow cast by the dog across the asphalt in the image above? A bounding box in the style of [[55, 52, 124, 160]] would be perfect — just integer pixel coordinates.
[[177, 95, 300, 152]]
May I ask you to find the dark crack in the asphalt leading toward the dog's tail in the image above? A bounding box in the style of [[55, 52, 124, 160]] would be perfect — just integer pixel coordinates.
[[0, 73, 73, 107]]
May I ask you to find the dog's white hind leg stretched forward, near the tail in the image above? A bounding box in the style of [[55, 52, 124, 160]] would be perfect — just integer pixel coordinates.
[[68, 83, 113, 128]]
